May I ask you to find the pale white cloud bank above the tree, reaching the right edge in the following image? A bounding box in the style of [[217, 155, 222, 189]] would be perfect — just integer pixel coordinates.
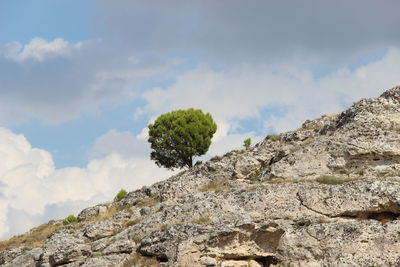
[[137, 49, 400, 132]]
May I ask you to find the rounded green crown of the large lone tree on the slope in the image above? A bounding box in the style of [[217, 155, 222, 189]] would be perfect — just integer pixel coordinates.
[[148, 108, 217, 169]]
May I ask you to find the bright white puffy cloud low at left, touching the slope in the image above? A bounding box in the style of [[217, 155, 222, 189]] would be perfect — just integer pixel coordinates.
[[0, 128, 171, 239]]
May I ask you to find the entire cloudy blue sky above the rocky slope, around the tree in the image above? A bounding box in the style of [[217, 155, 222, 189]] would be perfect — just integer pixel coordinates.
[[0, 0, 400, 240]]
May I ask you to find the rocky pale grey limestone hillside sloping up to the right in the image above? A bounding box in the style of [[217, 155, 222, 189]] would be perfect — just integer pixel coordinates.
[[0, 87, 400, 267]]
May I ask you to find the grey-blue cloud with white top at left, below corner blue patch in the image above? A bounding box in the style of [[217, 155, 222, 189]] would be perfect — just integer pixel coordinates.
[[0, 38, 177, 126]]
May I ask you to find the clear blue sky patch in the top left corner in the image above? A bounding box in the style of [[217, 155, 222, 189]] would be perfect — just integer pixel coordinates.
[[0, 0, 96, 44]]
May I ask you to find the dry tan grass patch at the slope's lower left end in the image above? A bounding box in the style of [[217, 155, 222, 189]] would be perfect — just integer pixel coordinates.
[[0, 221, 62, 251]]
